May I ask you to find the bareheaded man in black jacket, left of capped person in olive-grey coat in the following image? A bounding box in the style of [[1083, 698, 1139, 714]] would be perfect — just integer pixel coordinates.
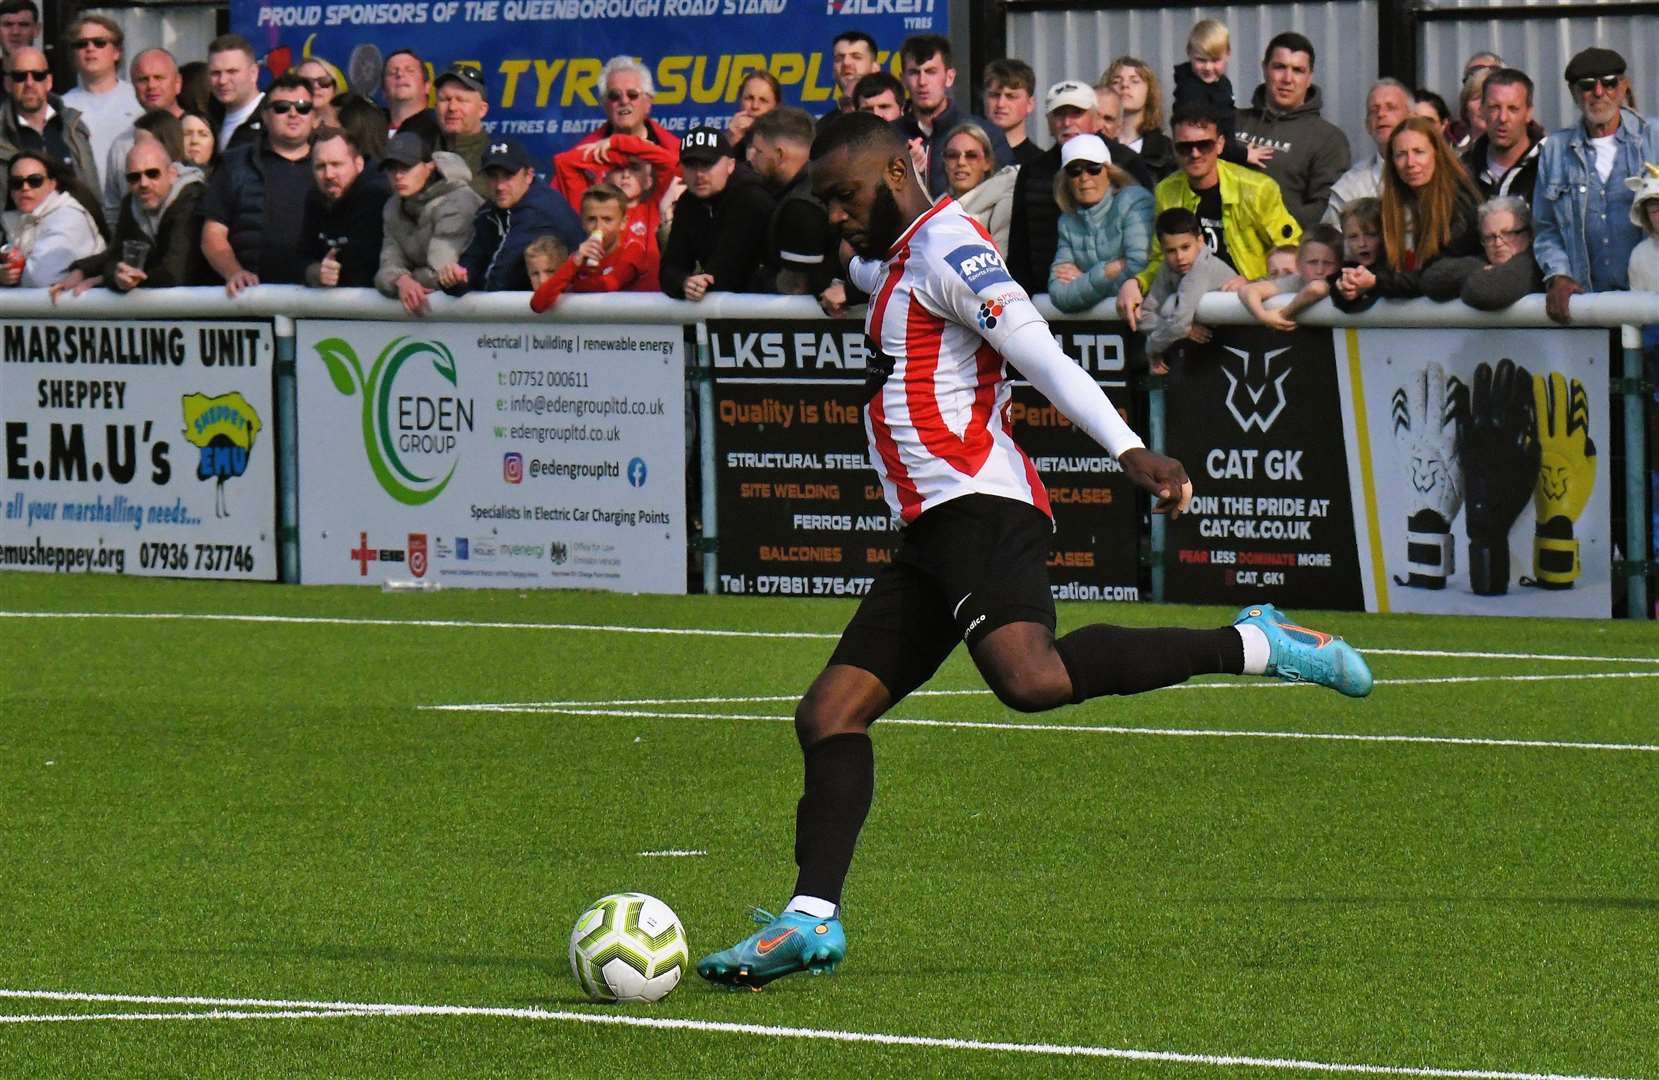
[[300, 128, 392, 289]]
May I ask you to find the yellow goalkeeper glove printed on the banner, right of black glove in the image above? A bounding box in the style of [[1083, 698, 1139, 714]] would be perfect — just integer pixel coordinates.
[[1523, 372, 1596, 589]]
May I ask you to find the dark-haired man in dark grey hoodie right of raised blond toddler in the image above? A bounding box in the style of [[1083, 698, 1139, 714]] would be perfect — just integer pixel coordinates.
[[1236, 32, 1350, 229]]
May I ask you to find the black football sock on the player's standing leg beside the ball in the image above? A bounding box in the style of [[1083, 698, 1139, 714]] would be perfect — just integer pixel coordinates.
[[795, 732, 876, 904]]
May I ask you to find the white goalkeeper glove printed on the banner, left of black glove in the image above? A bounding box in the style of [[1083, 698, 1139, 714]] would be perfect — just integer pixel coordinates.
[[1392, 362, 1468, 589]]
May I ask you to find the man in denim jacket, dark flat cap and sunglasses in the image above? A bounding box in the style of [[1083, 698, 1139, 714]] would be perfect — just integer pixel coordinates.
[[1533, 48, 1659, 324]]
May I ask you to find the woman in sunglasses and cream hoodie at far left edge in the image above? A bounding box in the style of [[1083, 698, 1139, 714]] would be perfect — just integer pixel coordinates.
[[0, 149, 108, 289]]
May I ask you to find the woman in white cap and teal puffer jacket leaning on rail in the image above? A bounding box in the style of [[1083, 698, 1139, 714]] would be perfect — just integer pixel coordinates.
[[1048, 134, 1153, 312]]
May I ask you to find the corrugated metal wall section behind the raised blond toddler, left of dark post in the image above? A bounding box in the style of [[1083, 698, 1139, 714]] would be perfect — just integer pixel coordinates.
[[1007, 0, 1377, 158]]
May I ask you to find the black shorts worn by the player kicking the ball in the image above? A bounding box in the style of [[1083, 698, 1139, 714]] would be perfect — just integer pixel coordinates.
[[830, 494, 1055, 702]]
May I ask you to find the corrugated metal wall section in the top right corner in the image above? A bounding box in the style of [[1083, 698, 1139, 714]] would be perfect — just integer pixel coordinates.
[[1417, 0, 1659, 137]]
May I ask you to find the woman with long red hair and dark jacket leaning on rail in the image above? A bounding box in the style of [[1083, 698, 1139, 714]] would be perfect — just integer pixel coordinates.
[[1332, 116, 1481, 310]]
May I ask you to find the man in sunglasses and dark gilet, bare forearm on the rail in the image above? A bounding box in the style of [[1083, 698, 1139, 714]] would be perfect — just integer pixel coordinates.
[[201, 71, 317, 297]]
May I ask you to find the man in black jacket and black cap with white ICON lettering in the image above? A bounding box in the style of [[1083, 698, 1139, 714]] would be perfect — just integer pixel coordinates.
[[660, 128, 773, 300]]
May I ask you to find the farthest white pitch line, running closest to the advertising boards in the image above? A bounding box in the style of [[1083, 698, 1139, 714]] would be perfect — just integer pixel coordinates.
[[0, 611, 1659, 664]]
